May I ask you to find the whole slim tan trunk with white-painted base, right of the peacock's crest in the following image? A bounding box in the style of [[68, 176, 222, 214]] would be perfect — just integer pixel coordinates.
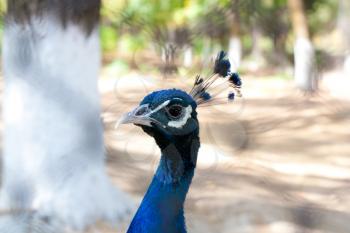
[[288, 0, 317, 92]]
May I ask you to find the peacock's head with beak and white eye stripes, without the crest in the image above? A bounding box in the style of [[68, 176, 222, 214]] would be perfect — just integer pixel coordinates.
[[120, 89, 199, 148]]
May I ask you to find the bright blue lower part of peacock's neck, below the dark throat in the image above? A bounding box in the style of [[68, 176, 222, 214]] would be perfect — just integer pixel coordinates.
[[127, 157, 194, 233]]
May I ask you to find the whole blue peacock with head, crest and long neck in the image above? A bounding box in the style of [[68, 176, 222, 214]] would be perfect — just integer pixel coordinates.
[[119, 51, 242, 233]]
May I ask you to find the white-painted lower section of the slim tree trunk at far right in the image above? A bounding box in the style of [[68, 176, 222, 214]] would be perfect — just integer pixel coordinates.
[[294, 38, 317, 91]]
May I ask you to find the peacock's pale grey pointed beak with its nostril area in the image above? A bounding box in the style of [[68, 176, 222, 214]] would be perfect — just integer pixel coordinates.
[[115, 104, 154, 128]]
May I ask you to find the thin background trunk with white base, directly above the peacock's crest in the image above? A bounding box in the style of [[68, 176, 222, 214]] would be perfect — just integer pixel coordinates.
[[228, 0, 242, 72]]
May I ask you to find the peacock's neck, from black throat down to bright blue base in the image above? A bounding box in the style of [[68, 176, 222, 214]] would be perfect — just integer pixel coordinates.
[[128, 130, 200, 233]]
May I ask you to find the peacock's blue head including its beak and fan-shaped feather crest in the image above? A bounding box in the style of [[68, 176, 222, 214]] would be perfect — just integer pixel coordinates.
[[119, 52, 241, 147]]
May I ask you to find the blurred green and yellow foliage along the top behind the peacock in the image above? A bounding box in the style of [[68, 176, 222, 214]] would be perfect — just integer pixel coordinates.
[[0, 0, 339, 72]]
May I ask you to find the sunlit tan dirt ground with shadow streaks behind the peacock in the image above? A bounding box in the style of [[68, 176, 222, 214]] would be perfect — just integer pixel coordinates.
[[100, 69, 350, 233]]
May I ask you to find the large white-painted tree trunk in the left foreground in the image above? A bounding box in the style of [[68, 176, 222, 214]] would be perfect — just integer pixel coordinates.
[[0, 0, 130, 233]]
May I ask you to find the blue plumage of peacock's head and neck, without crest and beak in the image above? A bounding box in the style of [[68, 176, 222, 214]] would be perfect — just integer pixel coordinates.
[[123, 89, 200, 233]]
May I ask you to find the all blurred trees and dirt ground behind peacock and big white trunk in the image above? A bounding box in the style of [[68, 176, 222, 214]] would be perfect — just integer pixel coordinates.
[[0, 0, 350, 233]]
